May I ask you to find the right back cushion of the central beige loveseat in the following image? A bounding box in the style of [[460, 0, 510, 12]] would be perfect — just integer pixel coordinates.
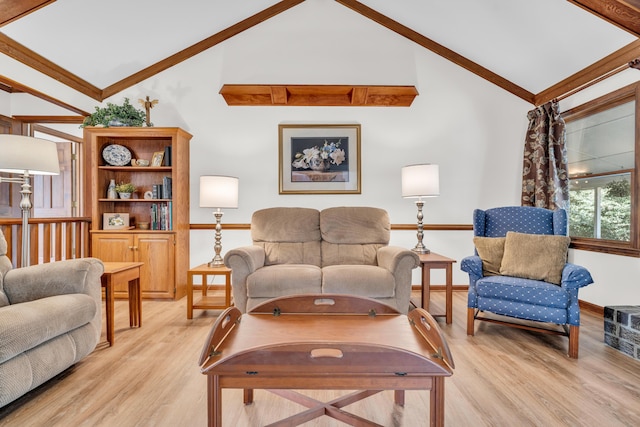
[[320, 206, 391, 267]]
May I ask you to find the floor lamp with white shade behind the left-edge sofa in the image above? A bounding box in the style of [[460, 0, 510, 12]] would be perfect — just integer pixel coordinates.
[[0, 134, 60, 267]]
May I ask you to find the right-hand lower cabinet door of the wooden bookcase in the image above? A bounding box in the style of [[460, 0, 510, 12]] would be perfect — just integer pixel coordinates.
[[134, 233, 176, 298]]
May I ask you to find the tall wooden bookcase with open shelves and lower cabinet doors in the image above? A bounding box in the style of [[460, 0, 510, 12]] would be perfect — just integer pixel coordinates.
[[81, 127, 192, 299]]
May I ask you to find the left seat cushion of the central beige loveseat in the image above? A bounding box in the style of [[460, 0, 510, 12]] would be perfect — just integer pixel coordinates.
[[247, 264, 322, 298]]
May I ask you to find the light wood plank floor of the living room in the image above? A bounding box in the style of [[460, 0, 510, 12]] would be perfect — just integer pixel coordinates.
[[0, 292, 640, 427]]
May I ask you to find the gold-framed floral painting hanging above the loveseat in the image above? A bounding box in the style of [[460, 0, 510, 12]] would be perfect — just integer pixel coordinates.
[[278, 124, 362, 194]]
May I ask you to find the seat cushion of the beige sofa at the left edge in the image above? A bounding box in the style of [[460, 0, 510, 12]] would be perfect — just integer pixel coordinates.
[[0, 294, 97, 363]]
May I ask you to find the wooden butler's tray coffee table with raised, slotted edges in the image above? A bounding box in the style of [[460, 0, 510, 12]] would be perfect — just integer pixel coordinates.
[[200, 294, 454, 426]]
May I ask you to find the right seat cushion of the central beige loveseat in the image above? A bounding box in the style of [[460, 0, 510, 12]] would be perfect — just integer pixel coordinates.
[[322, 265, 396, 298]]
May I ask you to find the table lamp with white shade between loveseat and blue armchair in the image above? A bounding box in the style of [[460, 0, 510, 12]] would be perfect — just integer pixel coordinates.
[[402, 164, 440, 254]]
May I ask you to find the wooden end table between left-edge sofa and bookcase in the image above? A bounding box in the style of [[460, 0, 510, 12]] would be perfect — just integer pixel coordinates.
[[100, 262, 144, 346]]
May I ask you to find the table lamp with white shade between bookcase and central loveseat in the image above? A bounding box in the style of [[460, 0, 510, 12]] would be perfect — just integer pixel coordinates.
[[200, 175, 238, 267]]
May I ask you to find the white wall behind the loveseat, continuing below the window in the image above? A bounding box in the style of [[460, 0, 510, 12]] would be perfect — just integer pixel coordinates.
[[5, 2, 640, 306]]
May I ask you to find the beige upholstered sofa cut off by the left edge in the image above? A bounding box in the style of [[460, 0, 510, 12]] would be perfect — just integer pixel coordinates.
[[0, 232, 103, 407]]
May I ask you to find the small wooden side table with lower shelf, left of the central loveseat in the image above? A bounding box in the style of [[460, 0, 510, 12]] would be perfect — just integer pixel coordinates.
[[187, 264, 231, 319]]
